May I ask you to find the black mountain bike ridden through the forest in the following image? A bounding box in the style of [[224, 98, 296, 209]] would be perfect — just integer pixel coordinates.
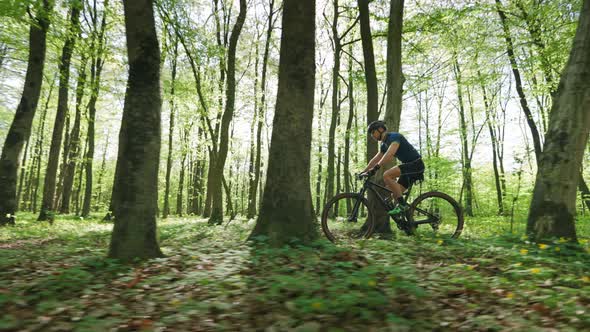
[[322, 173, 463, 242]]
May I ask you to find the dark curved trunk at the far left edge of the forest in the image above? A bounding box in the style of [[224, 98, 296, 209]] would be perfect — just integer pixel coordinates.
[[0, 0, 53, 225]]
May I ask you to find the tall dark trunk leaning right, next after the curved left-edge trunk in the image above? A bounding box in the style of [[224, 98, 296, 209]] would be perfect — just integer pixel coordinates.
[[38, 2, 81, 221]]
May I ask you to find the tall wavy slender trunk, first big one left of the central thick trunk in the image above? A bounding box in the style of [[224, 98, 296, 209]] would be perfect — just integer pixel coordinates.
[[209, 0, 246, 225]]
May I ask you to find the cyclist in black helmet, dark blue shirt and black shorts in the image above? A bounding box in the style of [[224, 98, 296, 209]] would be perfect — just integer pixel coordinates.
[[362, 121, 424, 216]]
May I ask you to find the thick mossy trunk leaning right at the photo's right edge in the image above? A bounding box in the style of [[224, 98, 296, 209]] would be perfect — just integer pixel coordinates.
[[527, 0, 590, 241]]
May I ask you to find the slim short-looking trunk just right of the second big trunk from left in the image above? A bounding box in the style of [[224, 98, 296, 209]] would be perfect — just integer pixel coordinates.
[[59, 57, 87, 213]]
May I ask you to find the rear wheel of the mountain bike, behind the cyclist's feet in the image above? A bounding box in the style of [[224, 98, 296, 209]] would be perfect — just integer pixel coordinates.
[[408, 191, 464, 238]]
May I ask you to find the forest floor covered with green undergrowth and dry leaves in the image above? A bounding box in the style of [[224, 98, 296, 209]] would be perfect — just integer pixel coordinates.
[[0, 215, 590, 331]]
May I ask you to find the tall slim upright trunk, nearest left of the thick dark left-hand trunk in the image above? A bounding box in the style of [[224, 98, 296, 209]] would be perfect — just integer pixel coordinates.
[[82, 0, 109, 218]]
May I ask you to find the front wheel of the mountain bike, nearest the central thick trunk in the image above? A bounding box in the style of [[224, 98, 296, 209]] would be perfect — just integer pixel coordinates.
[[322, 193, 375, 242]]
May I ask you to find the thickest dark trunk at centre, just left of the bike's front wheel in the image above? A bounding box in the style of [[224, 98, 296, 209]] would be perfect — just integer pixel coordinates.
[[250, 0, 317, 246]]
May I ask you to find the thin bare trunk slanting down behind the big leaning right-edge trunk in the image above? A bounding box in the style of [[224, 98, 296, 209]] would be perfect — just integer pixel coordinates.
[[496, 0, 541, 164]]
